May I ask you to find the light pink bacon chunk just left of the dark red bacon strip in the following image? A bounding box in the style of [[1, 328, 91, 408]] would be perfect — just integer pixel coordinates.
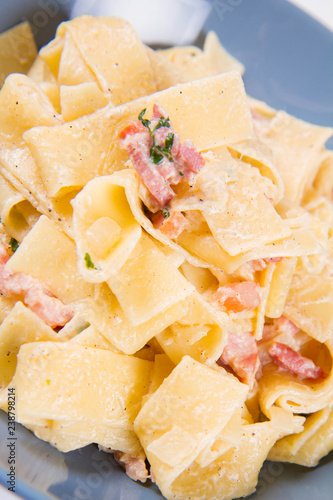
[[217, 332, 260, 388]]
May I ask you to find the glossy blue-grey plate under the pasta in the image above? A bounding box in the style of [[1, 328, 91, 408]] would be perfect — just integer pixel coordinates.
[[0, 0, 333, 500]]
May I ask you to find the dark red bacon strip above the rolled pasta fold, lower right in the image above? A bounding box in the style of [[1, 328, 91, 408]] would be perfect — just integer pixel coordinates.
[[268, 342, 326, 379]]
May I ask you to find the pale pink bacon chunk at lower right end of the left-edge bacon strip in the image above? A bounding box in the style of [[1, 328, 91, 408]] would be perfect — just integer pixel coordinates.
[[24, 284, 73, 328]]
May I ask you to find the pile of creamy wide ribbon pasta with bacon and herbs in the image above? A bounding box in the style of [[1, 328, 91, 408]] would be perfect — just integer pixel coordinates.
[[0, 16, 333, 500]]
